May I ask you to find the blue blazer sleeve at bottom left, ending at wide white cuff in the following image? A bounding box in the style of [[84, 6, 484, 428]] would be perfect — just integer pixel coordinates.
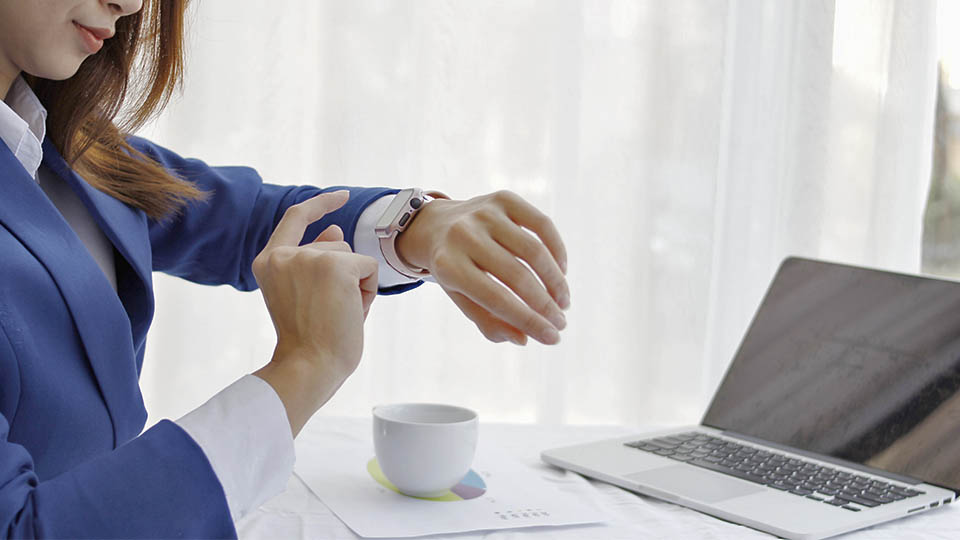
[[0, 402, 236, 538]]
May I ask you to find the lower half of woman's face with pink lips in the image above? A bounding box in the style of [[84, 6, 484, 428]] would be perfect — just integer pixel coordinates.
[[0, 0, 143, 93]]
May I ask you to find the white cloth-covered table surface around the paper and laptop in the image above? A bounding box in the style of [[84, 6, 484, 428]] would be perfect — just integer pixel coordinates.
[[237, 417, 960, 540]]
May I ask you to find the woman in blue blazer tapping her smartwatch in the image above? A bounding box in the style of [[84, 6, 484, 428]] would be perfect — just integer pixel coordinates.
[[0, 0, 569, 537]]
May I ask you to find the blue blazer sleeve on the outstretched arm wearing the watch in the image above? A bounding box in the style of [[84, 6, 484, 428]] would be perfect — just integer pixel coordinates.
[[129, 137, 420, 294]]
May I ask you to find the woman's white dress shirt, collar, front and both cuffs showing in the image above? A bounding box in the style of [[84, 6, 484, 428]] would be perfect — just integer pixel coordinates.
[[0, 77, 412, 520]]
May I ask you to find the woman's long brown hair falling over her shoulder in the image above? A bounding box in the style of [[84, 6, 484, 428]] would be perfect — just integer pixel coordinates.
[[26, 0, 204, 219]]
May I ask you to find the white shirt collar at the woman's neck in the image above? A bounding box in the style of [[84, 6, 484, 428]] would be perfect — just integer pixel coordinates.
[[0, 77, 47, 180]]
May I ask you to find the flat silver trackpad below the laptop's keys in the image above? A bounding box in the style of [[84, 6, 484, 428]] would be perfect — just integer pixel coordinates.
[[625, 465, 764, 503]]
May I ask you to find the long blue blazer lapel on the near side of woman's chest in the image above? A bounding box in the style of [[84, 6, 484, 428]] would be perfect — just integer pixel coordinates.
[[0, 144, 146, 445]]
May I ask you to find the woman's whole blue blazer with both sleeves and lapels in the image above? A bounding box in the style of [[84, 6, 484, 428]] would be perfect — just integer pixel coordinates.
[[0, 138, 410, 538]]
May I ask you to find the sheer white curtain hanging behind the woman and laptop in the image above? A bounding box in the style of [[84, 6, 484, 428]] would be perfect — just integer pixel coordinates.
[[142, 0, 936, 430]]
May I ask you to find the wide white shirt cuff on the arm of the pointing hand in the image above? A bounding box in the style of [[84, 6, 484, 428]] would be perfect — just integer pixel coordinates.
[[176, 375, 296, 520]]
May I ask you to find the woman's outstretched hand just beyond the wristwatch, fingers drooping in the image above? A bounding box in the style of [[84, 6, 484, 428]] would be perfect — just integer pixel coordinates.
[[397, 191, 570, 345]]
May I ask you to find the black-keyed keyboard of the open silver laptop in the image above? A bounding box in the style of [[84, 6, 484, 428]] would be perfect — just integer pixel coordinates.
[[625, 432, 924, 512]]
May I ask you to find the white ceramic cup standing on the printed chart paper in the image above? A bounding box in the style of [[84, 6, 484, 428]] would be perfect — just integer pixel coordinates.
[[373, 403, 478, 497]]
